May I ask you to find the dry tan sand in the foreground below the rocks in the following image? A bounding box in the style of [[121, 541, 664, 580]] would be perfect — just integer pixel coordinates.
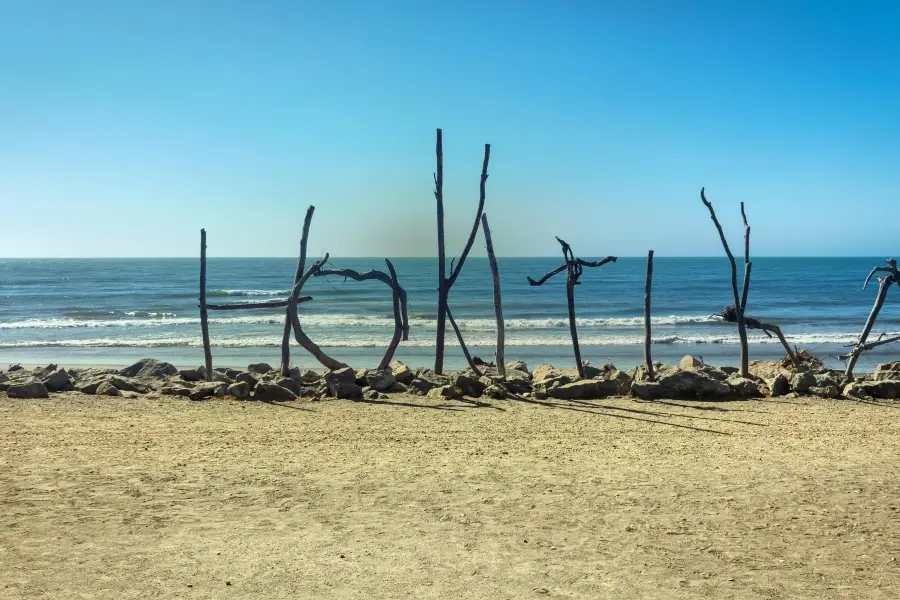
[[0, 393, 900, 599]]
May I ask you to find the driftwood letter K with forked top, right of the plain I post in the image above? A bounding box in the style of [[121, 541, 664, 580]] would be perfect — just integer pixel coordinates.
[[700, 188, 800, 377]]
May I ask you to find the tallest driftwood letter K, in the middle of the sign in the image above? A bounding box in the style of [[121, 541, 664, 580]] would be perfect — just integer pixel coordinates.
[[434, 129, 491, 373]]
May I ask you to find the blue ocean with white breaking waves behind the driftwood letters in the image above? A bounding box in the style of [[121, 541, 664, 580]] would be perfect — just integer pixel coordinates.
[[0, 257, 900, 372]]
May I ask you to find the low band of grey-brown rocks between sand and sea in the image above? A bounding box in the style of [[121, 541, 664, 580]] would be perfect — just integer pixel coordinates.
[[0, 356, 900, 402]]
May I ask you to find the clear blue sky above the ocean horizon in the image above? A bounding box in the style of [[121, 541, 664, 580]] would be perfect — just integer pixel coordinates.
[[0, 0, 900, 257]]
